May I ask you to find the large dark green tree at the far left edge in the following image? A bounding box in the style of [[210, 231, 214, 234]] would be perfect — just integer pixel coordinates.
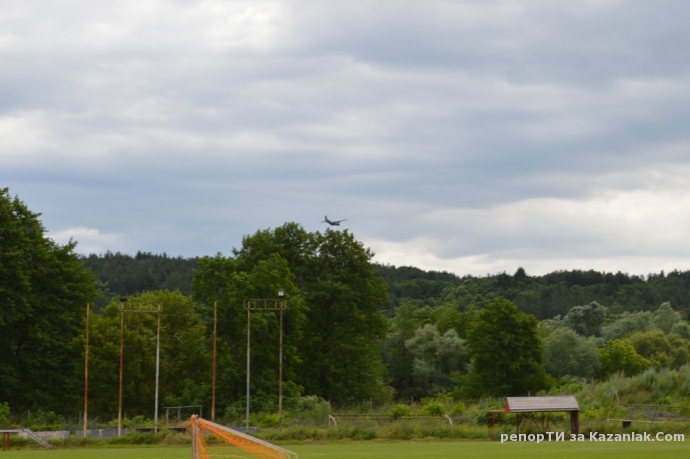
[[0, 188, 98, 412]]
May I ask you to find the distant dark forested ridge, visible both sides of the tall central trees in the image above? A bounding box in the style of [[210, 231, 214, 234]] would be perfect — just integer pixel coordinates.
[[80, 252, 690, 320]]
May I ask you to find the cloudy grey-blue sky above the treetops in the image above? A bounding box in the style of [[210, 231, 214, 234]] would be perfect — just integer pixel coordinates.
[[0, 0, 690, 275]]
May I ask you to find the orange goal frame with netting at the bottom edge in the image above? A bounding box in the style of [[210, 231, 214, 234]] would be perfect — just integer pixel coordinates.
[[191, 415, 298, 459]]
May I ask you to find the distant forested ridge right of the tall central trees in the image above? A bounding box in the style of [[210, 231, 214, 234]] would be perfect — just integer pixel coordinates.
[[376, 265, 690, 320]]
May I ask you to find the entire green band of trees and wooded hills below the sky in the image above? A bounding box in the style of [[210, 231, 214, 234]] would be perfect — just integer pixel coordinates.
[[0, 189, 690, 430]]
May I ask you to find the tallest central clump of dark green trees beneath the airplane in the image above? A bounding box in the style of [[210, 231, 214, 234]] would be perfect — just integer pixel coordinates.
[[194, 223, 386, 406]]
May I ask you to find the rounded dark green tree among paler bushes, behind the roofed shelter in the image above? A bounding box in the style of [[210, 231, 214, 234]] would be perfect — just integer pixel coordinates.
[[463, 298, 547, 397]]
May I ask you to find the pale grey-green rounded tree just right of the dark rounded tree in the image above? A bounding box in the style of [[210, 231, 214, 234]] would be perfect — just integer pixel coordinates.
[[544, 328, 601, 378]]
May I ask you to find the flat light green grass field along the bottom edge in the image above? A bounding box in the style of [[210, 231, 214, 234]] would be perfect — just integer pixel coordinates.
[[0, 440, 690, 459]]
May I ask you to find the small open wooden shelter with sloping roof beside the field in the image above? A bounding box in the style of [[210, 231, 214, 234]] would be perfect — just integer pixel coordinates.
[[489, 395, 580, 439]]
